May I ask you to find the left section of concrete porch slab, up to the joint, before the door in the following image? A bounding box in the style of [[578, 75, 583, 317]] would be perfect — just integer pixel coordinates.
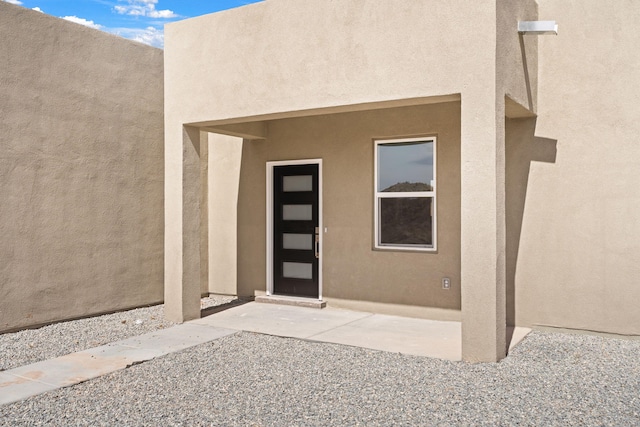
[[189, 302, 371, 338]]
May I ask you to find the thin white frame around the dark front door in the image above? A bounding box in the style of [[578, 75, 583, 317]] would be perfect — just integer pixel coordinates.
[[267, 159, 324, 300]]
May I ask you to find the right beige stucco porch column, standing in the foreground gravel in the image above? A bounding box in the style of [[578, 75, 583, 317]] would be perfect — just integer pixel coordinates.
[[461, 95, 507, 362]]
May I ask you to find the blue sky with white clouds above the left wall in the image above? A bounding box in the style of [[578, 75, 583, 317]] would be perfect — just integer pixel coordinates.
[[3, 0, 261, 48]]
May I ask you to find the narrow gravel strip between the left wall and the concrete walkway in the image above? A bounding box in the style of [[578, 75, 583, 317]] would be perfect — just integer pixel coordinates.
[[0, 296, 236, 371]]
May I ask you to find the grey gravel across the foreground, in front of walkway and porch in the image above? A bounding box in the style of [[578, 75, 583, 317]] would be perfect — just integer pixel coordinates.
[[0, 314, 640, 426]]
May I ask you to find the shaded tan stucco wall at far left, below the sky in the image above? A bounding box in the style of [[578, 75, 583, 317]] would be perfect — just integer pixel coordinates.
[[0, 2, 164, 331]]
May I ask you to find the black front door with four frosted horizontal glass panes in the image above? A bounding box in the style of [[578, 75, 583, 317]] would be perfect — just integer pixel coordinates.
[[273, 164, 320, 298]]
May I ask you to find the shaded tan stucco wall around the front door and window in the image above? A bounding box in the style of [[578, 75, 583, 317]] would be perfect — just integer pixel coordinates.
[[238, 103, 460, 314]]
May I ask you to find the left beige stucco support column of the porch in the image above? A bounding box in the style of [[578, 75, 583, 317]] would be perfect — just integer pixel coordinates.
[[164, 126, 201, 322]]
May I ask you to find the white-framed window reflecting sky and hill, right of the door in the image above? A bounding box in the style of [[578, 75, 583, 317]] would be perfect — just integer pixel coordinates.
[[374, 136, 436, 251]]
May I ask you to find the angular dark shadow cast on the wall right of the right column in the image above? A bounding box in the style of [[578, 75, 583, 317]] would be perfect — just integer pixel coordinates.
[[505, 118, 557, 326]]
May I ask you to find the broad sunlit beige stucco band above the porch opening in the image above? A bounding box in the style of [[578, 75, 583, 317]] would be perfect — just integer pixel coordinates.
[[165, 0, 496, 123]]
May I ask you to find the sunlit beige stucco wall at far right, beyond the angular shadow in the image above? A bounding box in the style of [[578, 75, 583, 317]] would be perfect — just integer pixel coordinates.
[[514, 0, 640, 334]]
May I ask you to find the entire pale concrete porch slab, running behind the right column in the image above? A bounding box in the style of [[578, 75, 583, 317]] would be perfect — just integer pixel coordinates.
[[194, 302, 531, 361]]
